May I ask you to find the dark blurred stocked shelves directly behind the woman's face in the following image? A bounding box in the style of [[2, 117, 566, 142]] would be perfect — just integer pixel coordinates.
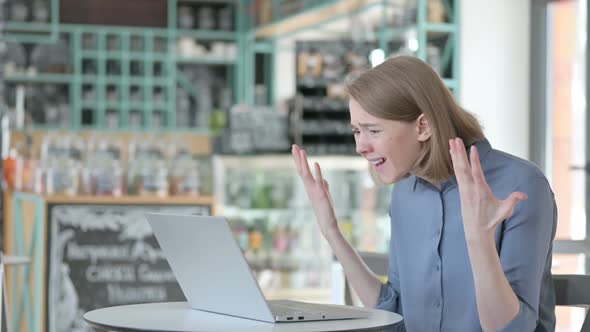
[[292, 40, 378, 155]]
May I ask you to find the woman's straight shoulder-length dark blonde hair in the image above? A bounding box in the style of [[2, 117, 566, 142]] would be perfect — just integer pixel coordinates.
[[347, 56, 484, 181]]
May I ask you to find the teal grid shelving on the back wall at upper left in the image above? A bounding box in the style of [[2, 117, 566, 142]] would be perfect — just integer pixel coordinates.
[[5, 0, 242, 132]]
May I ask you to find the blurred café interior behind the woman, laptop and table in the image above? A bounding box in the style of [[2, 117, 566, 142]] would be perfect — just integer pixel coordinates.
[[0, 0, 590, 332]]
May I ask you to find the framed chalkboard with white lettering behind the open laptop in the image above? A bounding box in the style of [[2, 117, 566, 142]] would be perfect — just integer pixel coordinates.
[[47, 205, 211, 332]]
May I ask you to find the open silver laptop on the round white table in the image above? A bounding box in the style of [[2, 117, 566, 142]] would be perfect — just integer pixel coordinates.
[[145, 213, 369, 323]]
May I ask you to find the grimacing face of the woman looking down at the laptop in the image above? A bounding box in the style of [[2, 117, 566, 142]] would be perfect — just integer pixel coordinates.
[[349, 98, 424, 183]]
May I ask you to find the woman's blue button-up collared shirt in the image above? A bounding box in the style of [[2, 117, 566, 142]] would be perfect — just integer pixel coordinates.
[[377, 140, 557, 332]]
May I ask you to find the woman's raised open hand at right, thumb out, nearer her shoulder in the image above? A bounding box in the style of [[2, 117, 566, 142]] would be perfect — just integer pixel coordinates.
[[449, 138, 528, 240]]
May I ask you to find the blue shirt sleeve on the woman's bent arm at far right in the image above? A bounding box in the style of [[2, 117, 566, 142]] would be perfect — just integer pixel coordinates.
[[498, 177, 557, 332]]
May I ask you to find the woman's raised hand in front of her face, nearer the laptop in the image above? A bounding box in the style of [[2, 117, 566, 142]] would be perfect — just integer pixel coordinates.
[[291, 144, 340, 238]]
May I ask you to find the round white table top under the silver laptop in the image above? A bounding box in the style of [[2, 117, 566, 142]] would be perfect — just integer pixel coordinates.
[[84, 302, 402, 332]]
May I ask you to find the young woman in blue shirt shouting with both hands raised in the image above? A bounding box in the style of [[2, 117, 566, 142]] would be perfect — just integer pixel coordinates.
[[292, 57, 557, 332]]
